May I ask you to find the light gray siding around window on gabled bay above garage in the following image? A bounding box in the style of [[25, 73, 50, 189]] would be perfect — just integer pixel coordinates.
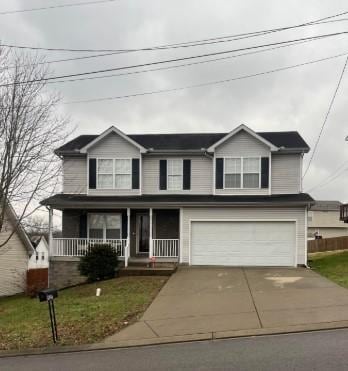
[[215, 130, 270, 195]]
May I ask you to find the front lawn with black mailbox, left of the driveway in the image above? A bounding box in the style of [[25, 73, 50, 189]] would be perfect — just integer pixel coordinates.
[[0, 277, 166, 350]]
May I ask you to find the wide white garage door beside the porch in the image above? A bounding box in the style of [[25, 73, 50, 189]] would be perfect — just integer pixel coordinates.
[[191, 221, 296, 266]]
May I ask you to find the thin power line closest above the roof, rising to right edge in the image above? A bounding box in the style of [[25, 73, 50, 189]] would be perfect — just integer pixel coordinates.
[[63, 52, 348, 104]]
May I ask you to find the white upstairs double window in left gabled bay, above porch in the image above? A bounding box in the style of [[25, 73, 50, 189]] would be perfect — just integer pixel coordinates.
[[97, 159, 132, 189]]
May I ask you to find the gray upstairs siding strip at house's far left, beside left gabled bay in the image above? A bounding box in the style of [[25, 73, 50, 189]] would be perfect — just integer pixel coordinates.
[[63, 157, 87, 194]]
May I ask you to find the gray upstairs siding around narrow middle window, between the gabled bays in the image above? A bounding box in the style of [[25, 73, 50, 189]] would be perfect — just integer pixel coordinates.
[[142, 156, 213, 194]]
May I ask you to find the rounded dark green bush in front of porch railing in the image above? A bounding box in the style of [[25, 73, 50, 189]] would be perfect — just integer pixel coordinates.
[[79, 244, 118, 282]]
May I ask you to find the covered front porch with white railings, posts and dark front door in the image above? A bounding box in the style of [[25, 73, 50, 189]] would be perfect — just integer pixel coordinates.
[[50, 208, 180, 266]]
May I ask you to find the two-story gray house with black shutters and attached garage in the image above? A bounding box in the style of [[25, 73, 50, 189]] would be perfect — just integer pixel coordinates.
[[41, 125, 313, 274]]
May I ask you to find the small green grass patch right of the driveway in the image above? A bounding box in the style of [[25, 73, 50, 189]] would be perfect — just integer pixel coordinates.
[[309, 251, 348, 288]]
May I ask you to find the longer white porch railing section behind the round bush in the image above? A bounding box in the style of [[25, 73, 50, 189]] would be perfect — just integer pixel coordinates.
[[51, 238, 127, 257]]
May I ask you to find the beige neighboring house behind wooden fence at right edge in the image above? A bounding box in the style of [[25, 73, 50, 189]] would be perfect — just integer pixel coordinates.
[[307, 201, 348, 239]]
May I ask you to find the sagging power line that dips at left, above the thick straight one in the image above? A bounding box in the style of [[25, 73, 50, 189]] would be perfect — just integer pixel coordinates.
[[0, 11, 348, 54]]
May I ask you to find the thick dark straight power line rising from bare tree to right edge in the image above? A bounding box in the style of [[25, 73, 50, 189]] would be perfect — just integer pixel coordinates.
[[0, 31, 348, 87]]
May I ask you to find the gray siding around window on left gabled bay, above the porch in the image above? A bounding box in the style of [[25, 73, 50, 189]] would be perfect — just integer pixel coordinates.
[[88, 133, 141, 196]]
